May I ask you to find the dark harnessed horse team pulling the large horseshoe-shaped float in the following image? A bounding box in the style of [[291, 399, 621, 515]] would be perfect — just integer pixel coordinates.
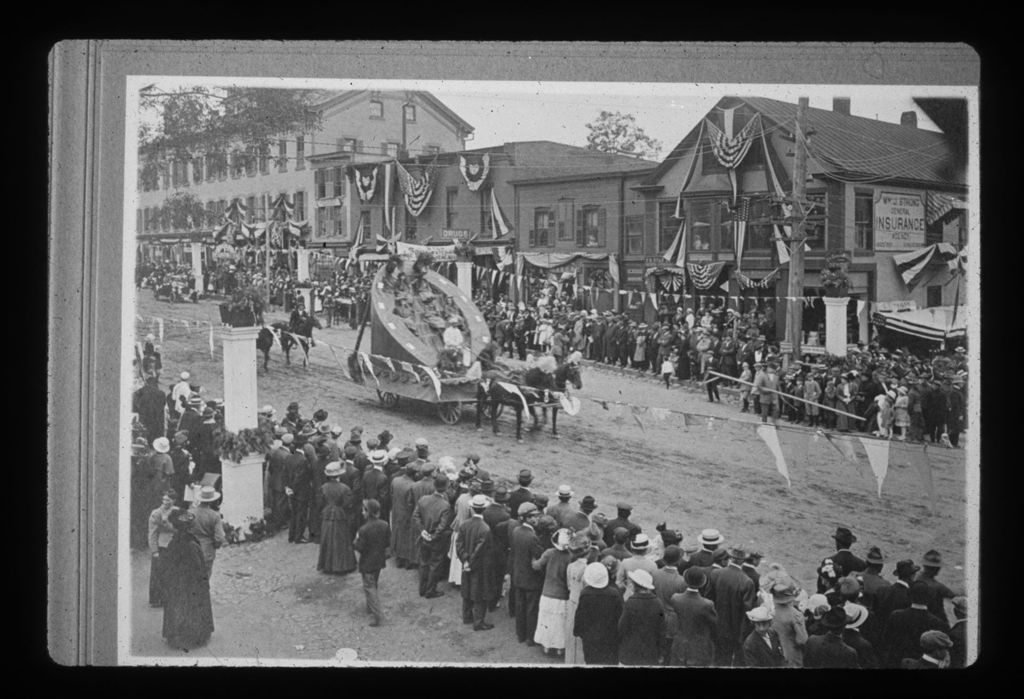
[[476, 363, 583, 442]]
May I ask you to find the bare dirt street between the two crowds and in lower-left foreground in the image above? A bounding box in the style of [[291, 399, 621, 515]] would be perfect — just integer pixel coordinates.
[[126, 291, 966, 663]]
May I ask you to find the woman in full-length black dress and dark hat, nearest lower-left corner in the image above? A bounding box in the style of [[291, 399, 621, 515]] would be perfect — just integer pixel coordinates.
[[161, 510, 213, 650]]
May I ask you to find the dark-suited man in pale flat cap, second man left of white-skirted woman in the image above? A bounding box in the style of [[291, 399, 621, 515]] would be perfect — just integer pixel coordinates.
[[456, 493, 498, 631]]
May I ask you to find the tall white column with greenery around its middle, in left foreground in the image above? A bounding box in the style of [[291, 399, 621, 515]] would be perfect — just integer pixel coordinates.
[[220, 327, 263, 533]]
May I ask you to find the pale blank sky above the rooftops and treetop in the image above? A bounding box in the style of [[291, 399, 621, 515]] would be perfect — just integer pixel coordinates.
[[134, 77, 942, 158]]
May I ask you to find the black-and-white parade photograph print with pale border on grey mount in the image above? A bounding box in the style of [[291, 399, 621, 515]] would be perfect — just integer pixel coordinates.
[[46, 40, 980, 669]]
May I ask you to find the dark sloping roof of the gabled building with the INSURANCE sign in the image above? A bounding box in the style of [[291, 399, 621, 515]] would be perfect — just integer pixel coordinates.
[[644, 97, 967, 186]]
